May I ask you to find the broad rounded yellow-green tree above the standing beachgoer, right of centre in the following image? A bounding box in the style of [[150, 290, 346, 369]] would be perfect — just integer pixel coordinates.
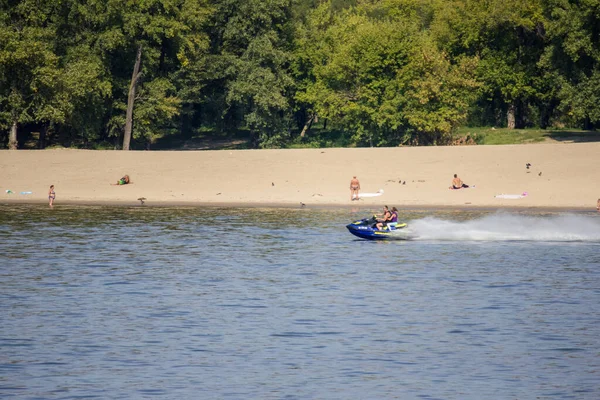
[[297, 1, 478, 146]]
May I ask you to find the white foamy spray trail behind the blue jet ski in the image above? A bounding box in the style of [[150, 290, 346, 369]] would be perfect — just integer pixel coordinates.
[[409, 213, 600, 242]]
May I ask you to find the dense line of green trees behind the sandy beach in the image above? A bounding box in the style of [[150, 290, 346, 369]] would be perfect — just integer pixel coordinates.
[[0, 0, 600, 149]]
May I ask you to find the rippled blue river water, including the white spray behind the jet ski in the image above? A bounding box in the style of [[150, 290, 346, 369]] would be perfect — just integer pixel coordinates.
[[0, 206, 600, 399]]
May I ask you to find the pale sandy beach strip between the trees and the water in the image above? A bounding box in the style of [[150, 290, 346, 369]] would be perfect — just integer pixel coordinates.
[[0, 143, 600, 210]]
